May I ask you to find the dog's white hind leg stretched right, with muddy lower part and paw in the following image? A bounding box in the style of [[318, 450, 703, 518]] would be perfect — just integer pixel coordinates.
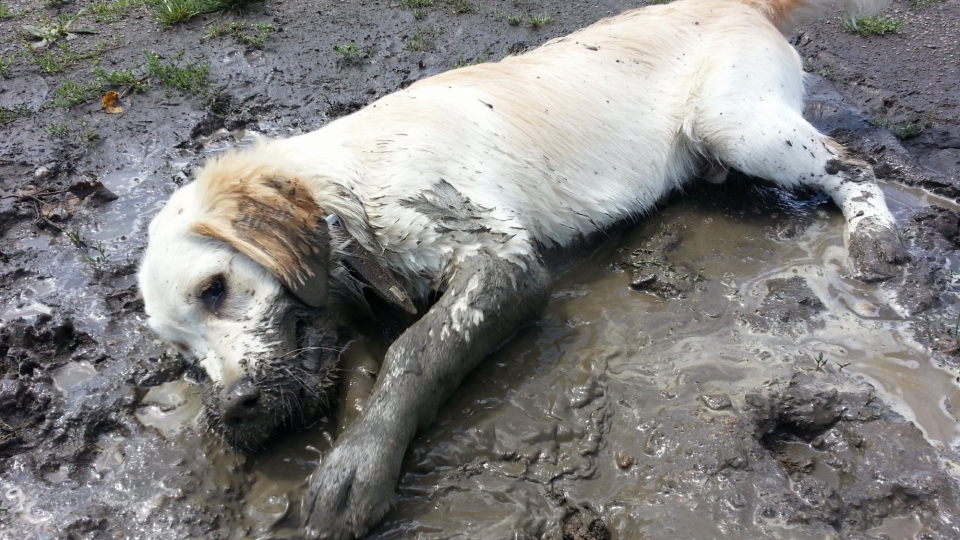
[[696, 106, 908, 282]]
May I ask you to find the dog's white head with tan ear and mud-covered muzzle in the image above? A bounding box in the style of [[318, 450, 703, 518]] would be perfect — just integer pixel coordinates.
[[139, 155, 339, 447]]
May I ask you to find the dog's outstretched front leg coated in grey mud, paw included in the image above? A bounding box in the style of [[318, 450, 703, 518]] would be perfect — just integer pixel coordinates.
[[302, 251, 550, 539]]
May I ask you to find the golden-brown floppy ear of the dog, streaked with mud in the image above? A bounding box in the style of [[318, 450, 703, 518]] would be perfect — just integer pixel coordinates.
[[192, 176, 330, 307]]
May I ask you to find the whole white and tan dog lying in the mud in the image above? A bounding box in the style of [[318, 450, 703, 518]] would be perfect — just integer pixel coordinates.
[[139, 0, 905, 538]]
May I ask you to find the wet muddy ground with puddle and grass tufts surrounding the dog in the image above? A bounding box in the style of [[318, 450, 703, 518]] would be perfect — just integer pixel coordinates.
[[0, 0, 960, 540]]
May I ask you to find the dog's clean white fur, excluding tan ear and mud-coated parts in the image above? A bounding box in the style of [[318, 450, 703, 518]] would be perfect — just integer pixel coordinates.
[[140, 0, 893, 392]]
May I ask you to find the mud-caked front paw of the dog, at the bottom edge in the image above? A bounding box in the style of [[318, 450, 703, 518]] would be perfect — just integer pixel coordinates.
[[302, 441, 402, 540]]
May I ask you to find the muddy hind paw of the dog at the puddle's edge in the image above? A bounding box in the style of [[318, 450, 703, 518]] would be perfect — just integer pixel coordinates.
[[848, 219, 910, 283]]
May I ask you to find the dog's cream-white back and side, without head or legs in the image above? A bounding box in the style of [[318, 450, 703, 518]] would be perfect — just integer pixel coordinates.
[[268, 0, 883, 286]]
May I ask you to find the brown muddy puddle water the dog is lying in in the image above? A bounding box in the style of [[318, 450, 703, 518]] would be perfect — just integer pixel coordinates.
[[56, 178, 948, 539]]
